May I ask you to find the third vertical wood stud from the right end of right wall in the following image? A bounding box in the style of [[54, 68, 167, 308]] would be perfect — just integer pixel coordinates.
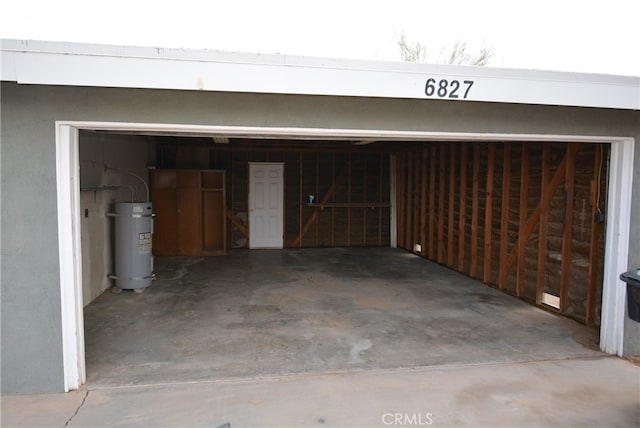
[[536, 143, 551, 305]]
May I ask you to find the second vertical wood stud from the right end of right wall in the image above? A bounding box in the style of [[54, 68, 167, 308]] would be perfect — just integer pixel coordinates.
[[560, 143, 577, 313]]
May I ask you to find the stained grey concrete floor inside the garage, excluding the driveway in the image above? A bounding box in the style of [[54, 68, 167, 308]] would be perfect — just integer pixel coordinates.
[[85, 248, 601, 386]]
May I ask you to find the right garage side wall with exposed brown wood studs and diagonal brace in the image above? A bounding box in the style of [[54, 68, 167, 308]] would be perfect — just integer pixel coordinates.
[[396, 142, 609, 324]]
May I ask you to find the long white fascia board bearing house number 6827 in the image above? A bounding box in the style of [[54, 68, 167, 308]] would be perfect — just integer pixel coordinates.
[[2, 40, 640, 110]]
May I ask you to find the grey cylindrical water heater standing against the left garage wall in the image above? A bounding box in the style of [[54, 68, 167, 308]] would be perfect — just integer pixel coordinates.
[[110, 202, 153, 292]]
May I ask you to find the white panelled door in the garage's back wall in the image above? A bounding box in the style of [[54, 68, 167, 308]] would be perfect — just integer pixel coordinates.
[[249, 162, 284, 248]]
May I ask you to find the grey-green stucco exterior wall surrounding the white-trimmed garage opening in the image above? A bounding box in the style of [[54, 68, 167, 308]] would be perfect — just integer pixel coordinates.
[[0, 82, 640, 393]]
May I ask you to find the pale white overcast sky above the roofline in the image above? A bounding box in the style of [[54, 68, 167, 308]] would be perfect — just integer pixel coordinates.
[[0, 0, 640, 76]]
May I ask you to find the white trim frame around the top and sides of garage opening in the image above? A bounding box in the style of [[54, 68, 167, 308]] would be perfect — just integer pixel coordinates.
[[56, 121, 635, 391]]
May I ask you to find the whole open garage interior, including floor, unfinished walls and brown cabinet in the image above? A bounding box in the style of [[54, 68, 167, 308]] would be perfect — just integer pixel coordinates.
[[80, 131, 609, 385]]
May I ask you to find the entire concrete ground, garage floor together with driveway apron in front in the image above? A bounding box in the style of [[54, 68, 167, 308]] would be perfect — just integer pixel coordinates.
[[1, 249, 640, 428]]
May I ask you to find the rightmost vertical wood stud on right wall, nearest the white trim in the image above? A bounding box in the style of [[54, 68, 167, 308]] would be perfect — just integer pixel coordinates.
[[585, 144, 604, 325]]
